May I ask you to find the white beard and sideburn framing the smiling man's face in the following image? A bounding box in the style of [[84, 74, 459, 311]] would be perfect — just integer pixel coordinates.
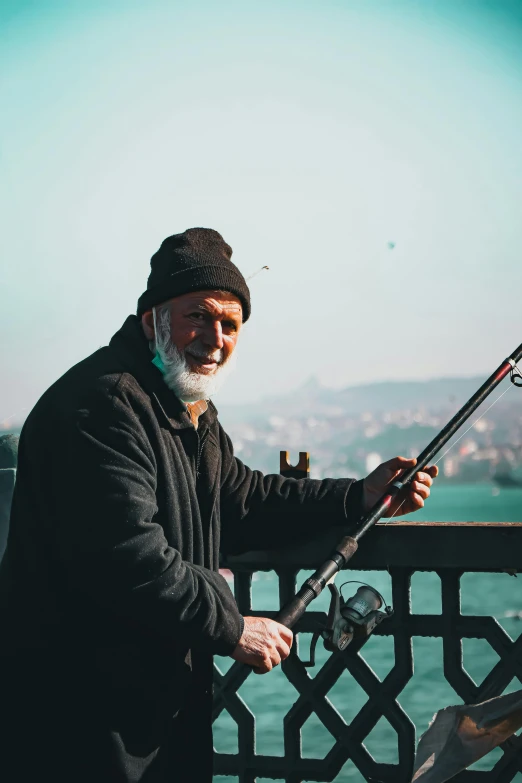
[[152, 307, 235, 402]]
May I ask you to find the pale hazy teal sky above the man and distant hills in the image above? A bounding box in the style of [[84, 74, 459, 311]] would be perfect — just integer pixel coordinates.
[[0, 0, 522, 421]]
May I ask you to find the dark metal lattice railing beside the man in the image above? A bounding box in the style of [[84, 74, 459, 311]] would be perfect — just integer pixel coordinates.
[[214, 522, 522, 783]]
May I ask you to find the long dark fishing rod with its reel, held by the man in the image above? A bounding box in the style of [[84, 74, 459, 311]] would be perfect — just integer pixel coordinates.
[[274, 344, 522, 666]]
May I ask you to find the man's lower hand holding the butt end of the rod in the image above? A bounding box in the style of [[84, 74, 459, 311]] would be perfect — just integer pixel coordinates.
[[230, 617, 294, 674]]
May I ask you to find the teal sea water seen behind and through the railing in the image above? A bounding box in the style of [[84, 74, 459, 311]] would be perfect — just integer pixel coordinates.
[[214, 484, 522, 783]]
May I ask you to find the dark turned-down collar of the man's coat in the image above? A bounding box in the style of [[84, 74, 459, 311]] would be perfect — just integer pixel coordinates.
[[109, 315, 217, 430]]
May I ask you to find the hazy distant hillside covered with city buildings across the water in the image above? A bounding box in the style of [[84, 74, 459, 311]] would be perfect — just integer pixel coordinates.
[[218, 377, 522, 482]]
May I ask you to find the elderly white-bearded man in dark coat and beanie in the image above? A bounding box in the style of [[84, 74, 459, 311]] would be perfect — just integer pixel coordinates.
[[0, 228, 436, 783]]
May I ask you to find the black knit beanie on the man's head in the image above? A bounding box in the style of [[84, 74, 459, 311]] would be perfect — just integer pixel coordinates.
[[137, 228, 250, 321]]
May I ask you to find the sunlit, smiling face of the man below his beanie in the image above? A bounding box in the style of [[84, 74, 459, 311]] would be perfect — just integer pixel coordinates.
[[162, 291, 243, 375]]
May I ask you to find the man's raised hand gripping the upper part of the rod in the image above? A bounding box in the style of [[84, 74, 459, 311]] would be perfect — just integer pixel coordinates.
[[363, 457, 439, 517]]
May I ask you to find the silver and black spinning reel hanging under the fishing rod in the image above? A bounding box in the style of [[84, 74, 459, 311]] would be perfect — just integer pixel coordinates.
[[303, 581, 393, 666]]
